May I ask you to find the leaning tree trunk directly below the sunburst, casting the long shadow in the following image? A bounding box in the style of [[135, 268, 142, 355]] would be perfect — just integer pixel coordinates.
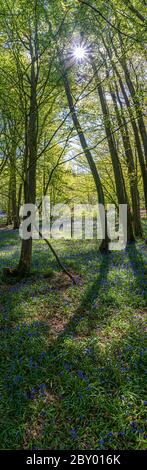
[[63, 70, 109, 252]]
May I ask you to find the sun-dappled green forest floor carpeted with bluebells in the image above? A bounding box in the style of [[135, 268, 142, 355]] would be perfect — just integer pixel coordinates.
[[0, 224, 147, 450]]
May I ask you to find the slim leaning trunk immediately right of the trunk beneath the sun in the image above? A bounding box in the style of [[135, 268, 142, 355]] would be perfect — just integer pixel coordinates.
[[92, 60, 134, 242]]
